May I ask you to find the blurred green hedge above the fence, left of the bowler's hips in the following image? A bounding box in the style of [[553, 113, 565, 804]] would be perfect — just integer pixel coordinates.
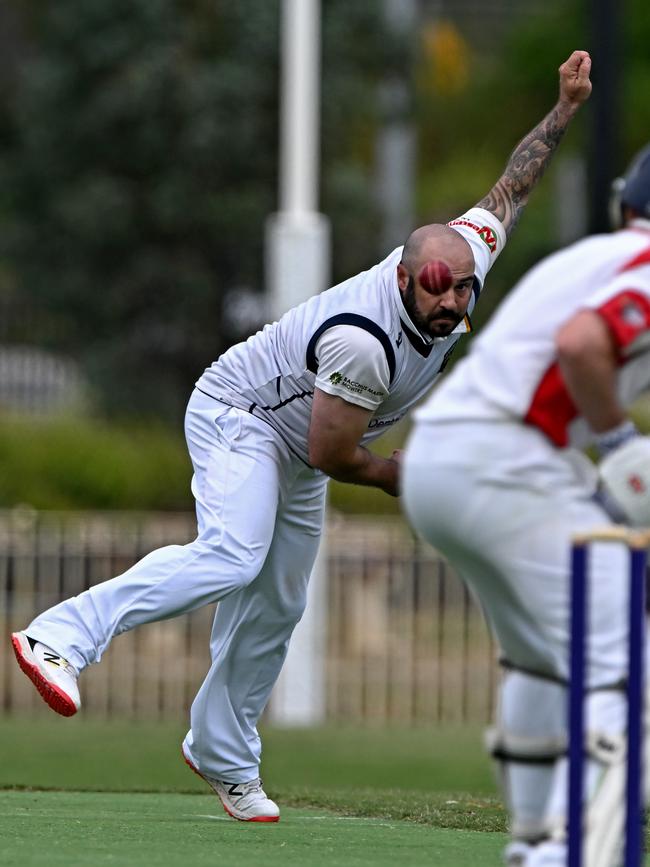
[[0, 419, 193, 510]]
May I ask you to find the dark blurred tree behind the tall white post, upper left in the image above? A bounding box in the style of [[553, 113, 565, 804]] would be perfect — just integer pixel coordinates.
[[0, 0, 390, 418]]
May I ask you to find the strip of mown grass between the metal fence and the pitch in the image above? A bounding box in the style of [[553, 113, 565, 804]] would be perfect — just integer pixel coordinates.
[[0, 706, 495, 800]]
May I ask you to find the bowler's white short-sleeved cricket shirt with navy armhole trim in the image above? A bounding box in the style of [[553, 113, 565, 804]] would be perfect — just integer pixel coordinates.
[[196, 208, 506, 463]]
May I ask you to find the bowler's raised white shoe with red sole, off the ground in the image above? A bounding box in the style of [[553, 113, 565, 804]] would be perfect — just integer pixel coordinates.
[[11, 632, 81, 716]]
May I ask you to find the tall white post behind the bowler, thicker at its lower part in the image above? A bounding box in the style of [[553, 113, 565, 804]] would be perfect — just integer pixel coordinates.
[[266, 0, 330, 726]]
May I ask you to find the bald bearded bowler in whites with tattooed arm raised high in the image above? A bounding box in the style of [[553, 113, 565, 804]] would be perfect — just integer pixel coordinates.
[[13, 51, 591, 821]]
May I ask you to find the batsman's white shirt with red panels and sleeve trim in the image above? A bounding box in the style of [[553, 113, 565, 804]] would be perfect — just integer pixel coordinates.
[[416, 220, 650, 447]]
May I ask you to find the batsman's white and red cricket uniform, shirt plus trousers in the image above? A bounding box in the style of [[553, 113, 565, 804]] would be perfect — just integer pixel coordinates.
[[404, 221, 650, 680]]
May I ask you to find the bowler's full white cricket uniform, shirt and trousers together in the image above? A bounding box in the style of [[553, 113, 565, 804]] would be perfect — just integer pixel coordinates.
[[25, 208, 505, 783]]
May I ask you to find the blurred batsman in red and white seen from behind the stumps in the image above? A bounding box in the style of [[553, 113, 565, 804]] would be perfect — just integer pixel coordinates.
[[403, 147, 650, 867]]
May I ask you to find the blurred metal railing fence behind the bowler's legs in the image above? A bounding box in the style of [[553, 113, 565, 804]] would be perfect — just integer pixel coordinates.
[[0, 509, 497, 724]]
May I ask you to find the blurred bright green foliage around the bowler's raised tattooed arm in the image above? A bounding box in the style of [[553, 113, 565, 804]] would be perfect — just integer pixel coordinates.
[[410, 0, 650, 328]]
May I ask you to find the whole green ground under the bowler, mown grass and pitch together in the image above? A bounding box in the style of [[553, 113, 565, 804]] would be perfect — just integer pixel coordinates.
[[0, 708, 644, 867]]
